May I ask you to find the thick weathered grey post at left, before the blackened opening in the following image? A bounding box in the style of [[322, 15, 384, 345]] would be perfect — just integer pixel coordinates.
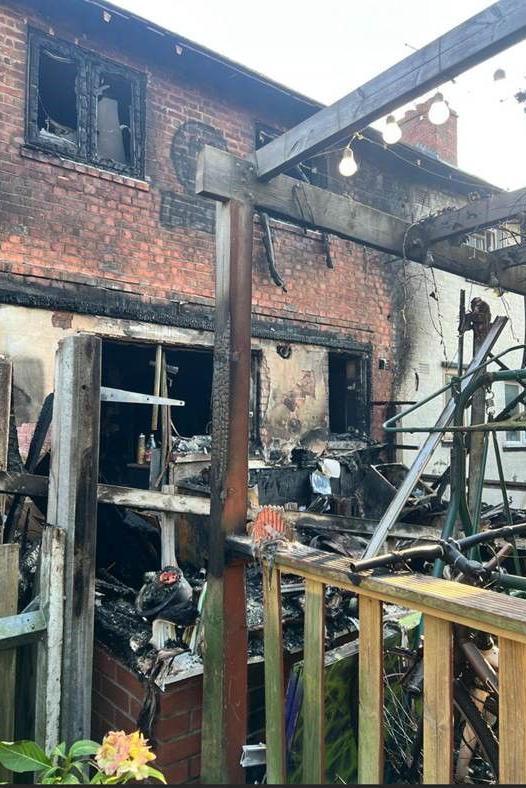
[[48, 334, 101, 744]]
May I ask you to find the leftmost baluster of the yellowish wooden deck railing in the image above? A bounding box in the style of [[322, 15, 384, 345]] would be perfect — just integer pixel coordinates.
[[263, 566, 287, 785]]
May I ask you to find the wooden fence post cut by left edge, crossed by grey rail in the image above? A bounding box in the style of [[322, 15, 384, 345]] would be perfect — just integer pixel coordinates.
[[0, 544, 18, 782]]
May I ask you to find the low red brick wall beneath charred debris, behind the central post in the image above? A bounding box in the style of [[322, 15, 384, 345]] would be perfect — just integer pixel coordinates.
[[92, 645, 265, 785]]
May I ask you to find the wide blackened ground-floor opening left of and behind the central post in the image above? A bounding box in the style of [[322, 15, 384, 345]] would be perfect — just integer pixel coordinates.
[[100, 340, 259, 488]]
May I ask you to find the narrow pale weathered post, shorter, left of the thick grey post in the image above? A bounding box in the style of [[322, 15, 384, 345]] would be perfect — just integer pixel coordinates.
[[35, 526, 66, 752]]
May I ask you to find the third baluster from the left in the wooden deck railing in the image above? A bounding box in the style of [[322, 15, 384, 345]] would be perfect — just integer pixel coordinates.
[[358, 596, 384, 785]]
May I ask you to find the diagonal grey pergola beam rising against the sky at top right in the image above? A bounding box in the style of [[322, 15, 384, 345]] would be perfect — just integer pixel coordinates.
[[256, 0, 526, 180]]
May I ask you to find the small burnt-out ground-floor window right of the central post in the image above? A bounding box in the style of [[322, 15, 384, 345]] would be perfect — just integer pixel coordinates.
[[329, 352, 369, 435]]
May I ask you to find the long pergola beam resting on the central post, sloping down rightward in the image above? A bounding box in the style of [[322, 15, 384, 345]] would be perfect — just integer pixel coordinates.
[[196, 146, 526, 295]]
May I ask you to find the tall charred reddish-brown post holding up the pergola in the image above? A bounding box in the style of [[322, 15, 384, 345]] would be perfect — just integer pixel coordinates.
[[201, 200, 254, 784]]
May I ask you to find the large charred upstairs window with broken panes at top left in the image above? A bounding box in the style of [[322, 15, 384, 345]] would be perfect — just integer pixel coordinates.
[[26, 31, 144, 178]]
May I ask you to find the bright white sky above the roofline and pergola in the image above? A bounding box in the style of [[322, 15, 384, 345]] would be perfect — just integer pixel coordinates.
[[113, 0, 526, 189]]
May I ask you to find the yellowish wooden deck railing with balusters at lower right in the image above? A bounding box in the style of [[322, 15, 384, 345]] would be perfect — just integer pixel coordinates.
[[231, 537, 526, 784]]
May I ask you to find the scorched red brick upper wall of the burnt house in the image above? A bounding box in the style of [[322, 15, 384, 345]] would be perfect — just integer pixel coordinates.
[[0, 5, 397, 438]]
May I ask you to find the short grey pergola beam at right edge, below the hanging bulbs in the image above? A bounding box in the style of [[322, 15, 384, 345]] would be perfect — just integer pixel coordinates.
[[407, 189, 526, 246]]
